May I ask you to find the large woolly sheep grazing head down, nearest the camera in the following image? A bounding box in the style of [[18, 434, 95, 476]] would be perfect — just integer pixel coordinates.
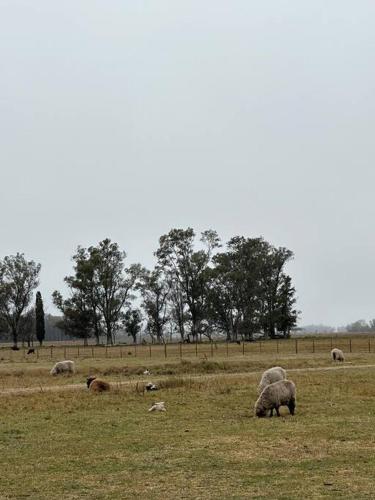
[[255, 380, 296, 417]]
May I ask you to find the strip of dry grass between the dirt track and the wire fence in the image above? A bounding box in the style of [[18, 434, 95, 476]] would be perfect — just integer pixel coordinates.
[[0, 352, 375, 392]]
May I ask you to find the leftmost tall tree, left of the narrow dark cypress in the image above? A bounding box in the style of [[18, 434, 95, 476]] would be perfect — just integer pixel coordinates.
[[0, 253, 41, 347]]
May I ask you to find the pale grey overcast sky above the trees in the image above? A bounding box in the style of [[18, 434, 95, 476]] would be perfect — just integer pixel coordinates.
[[0, 0, 375, 325]]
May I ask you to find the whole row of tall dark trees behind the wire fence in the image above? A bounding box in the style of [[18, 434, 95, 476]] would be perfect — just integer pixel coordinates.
[[0, 228, 298, 345]]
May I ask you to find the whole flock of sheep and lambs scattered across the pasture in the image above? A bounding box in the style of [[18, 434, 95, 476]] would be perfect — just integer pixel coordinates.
[[50, 348, 345, 417]]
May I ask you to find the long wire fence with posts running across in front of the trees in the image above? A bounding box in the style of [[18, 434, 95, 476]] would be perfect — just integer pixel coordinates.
[[0, 336, 375, 363]]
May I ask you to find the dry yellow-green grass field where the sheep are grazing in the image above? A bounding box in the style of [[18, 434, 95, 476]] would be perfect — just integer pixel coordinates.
[[0, 353, 375, 499]]
